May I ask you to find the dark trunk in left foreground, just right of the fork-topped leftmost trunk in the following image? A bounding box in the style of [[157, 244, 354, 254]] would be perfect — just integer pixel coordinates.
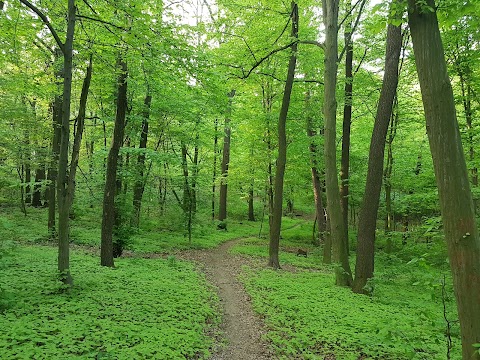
[[100, 58, 128, 267]]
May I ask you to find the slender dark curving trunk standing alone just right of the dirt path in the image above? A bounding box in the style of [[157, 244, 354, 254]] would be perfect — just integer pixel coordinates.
[[268, 1, 298, 269]]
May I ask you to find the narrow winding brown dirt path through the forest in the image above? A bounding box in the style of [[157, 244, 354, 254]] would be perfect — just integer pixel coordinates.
[[181, 239, 275, 360]]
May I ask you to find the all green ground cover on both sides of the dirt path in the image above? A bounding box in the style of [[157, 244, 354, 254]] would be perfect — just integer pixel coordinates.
[[0, 209, 460, 360]]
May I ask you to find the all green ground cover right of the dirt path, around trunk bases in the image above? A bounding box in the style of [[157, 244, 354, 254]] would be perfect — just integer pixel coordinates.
[[231, 223, 461, 360]]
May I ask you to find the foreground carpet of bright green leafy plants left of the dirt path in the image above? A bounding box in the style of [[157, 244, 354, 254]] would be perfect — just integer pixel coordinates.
[[0, 246, 218, 359]]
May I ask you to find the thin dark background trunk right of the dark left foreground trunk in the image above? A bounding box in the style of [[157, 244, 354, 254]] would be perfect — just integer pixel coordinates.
[[132, 94, 152, 228]]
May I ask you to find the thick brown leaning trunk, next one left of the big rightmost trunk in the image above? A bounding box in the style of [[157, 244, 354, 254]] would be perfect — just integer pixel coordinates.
[[352, 17, 402, 293]]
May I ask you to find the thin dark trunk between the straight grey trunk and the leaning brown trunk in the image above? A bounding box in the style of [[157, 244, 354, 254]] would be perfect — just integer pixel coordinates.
[[340, 0, 353, 253]]
